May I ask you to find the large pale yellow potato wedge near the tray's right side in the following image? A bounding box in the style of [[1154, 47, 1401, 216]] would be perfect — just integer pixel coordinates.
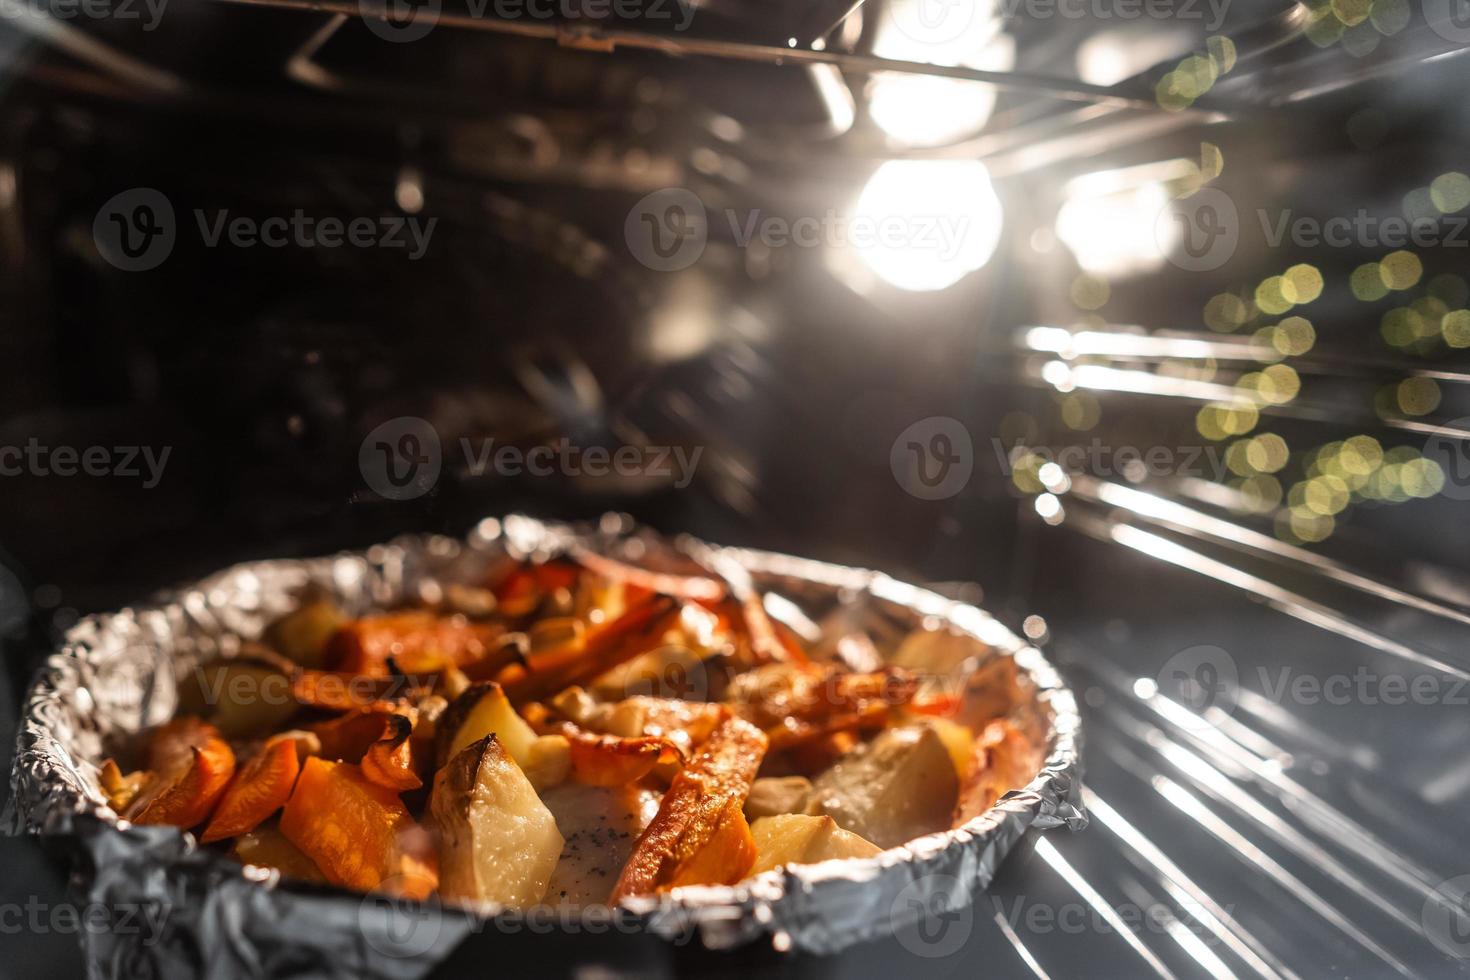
[[811, 726, 960, 848]]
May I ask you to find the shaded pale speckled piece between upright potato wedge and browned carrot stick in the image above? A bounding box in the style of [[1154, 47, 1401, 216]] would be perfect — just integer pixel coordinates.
[[542, 783, 659, 905]]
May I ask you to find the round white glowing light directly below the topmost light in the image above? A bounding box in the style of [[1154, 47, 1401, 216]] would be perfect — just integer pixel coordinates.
[[854, 160, 1001, 291]]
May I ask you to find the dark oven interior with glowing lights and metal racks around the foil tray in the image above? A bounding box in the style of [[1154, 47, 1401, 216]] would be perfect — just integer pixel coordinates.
[[0, 0, 1470, 977]]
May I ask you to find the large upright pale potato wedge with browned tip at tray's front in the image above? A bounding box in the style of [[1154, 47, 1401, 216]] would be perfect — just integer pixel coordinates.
[[429, 735, 564, 908]]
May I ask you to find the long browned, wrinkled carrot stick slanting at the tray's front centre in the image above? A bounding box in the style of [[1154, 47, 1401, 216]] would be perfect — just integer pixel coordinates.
[[612, 718, 766, 904]]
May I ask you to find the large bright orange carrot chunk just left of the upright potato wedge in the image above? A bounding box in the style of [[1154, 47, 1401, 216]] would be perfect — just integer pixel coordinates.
[[281, 757, 438, 898]]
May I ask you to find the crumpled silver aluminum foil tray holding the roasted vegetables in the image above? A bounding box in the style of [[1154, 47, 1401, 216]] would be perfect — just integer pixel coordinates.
[[10, 516, 1086, 977]]
